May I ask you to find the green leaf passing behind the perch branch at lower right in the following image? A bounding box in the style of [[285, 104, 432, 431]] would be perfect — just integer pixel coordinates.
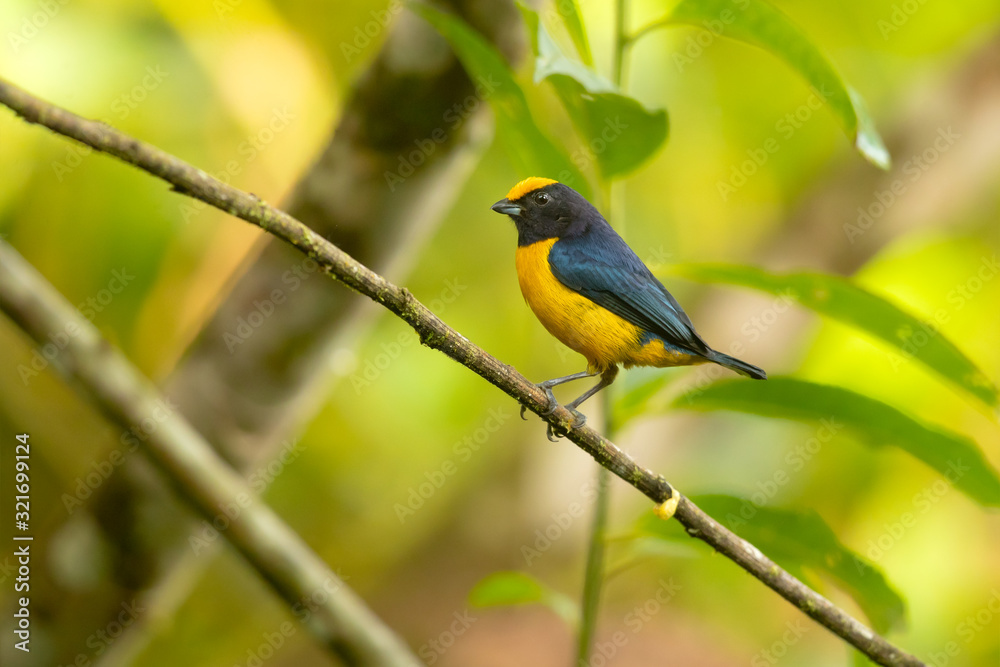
[[640, 495, 906, 633]]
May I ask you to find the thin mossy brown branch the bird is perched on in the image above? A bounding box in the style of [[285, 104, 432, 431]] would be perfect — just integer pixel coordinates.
[[0, 79, 924, 667]]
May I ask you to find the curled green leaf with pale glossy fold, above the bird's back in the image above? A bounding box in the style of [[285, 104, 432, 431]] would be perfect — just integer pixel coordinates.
[[520, 5, 668, 178]]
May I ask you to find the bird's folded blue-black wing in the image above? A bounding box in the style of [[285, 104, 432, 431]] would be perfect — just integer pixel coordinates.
[[549, 227, 711, 355]]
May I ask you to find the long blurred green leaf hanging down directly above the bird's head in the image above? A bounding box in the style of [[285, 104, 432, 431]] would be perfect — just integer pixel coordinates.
[[409, 3, 590, 199]]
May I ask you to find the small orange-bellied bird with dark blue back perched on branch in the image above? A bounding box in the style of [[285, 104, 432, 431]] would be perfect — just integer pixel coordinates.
[[490, 176, 767, 441]]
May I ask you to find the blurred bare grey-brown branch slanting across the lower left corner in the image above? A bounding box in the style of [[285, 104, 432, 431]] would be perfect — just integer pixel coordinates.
[[0, 241, 420, 667]]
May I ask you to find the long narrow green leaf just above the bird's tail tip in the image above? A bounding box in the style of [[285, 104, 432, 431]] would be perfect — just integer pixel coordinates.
[[670, 264, 1000, 410]]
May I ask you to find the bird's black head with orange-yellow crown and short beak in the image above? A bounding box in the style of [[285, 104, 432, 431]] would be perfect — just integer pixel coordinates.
[[491, 183, 599, 246]]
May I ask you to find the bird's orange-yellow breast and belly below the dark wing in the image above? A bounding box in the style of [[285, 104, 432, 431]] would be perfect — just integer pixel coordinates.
[[515, 239, 705, 373]]
